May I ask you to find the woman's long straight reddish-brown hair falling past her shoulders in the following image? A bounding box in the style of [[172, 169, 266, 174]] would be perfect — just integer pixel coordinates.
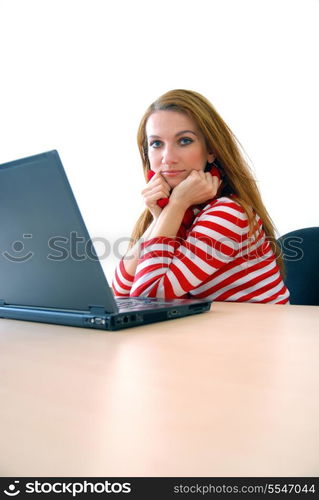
[[130, 89, 284, 271]]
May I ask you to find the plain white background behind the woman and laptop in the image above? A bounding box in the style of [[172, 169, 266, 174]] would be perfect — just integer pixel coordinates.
[[0, 0, 319, 279]]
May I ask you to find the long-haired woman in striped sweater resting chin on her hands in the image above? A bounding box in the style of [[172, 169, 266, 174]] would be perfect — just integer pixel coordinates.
[[113, 90, 289, 304]]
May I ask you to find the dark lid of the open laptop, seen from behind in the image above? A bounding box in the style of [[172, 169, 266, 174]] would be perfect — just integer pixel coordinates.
[[0, 151, 118, 312]]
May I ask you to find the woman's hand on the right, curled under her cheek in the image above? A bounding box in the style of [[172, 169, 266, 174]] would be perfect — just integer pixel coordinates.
[[170, 170, 221, 210]]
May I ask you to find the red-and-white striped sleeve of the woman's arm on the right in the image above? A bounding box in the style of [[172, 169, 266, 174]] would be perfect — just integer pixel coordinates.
[[130, 199, 248, 298]]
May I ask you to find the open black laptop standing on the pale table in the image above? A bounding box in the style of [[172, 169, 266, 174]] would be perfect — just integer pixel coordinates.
[[0, 150, 212, 330]]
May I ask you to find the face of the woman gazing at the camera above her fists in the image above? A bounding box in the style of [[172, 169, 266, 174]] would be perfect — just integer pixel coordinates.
[[146, 111, 215, 188]]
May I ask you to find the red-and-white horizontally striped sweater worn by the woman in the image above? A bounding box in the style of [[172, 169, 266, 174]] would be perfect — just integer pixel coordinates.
[[112, 197, 289, 304]]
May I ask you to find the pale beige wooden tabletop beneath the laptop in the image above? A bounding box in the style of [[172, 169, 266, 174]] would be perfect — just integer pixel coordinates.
[[0, 302, 319, 477]]
